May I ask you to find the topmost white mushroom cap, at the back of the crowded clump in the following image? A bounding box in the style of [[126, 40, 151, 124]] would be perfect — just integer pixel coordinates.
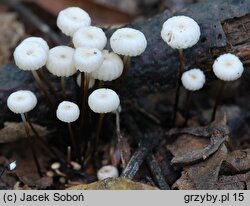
[[56, 7, 91, 37]]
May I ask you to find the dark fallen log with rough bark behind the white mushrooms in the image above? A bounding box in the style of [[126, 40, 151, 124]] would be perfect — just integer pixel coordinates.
[[0, 0, 250, 123]]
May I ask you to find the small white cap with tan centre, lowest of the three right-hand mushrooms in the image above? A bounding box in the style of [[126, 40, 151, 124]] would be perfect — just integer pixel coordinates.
[[181, 69, 206, 91]]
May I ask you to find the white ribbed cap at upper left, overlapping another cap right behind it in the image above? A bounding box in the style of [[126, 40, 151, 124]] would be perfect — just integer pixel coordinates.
[[13, 41, 48, 71]]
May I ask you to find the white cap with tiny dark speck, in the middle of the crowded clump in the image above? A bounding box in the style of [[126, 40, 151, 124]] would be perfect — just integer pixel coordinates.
[[73, 47, 103, 73]]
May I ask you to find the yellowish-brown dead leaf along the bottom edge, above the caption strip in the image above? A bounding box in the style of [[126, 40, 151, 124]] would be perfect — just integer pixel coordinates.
[[68, 178, 158, 190]]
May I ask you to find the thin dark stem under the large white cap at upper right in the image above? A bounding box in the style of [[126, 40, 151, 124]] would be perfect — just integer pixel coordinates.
[[172, 49, 185, 125]]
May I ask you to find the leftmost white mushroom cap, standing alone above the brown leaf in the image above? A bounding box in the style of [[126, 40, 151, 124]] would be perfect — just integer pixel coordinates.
[[7, 90, 37, 114]]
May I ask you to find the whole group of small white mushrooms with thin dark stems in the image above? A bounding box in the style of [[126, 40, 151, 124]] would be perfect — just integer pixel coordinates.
[[7, 7, 243, 182]]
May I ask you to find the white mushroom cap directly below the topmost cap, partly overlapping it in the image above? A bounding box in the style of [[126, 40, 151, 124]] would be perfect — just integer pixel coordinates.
[[72, 26, 107, 50]]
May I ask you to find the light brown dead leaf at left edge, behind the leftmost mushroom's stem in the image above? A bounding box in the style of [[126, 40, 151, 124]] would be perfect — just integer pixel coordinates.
[[0, 122, 48, 143]]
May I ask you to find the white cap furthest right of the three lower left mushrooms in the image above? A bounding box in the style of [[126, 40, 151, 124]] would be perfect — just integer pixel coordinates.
[[88, 88, 120, 113]]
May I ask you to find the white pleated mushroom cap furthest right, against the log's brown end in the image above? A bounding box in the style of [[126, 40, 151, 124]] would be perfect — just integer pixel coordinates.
[[213, 53, 244, 81]]
